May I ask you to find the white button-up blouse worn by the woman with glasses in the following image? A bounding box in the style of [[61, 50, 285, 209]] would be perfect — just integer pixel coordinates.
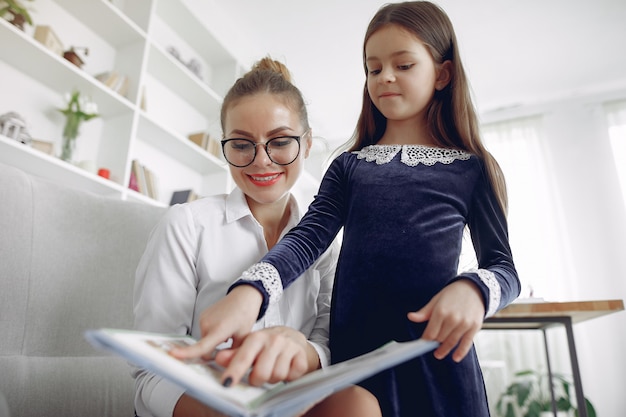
[[133, 188, 337, 417]]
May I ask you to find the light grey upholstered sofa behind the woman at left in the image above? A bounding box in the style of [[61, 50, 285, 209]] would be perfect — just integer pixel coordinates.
[[0, 164, 165, 417]]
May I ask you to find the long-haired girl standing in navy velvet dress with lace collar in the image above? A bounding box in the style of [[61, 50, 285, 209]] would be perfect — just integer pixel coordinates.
[[174, 1, 520, 417]]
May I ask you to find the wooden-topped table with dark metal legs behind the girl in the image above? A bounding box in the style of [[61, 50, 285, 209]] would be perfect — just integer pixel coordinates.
[[483, 300, 624, 417]]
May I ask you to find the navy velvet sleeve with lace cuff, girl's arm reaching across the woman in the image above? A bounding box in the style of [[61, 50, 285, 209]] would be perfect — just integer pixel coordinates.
[[229, 153, 348, 318]]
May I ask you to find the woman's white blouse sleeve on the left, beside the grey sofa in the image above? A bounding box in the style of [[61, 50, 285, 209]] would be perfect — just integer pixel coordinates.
[[132, 205, 196, 417]]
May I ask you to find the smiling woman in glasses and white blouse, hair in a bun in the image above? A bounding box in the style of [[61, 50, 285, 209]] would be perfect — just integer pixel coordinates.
[[134, 58, 379, 417]]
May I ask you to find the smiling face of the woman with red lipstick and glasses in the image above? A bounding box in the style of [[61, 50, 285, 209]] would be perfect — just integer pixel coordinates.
[[224, 93, 311, 205]]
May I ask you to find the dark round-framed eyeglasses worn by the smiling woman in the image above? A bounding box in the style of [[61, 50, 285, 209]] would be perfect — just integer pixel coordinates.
[[222, 131, 308, 168]]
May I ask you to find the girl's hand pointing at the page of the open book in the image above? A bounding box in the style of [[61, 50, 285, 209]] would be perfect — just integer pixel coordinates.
[[170, 285, 263, 377]]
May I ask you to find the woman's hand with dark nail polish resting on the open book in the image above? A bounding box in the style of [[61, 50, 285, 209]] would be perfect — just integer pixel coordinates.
[[215, 326, 320, 386]]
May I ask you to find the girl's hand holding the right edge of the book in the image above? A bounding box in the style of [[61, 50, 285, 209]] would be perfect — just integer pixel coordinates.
[[408, 279, 485, 362]]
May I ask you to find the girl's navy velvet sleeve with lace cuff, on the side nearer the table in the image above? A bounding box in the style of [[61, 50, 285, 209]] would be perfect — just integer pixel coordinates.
[[457, 162, 521, 317]]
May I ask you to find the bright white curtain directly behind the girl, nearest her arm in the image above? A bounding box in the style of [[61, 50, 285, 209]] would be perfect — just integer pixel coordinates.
[[465, 116, 572, 416]]
